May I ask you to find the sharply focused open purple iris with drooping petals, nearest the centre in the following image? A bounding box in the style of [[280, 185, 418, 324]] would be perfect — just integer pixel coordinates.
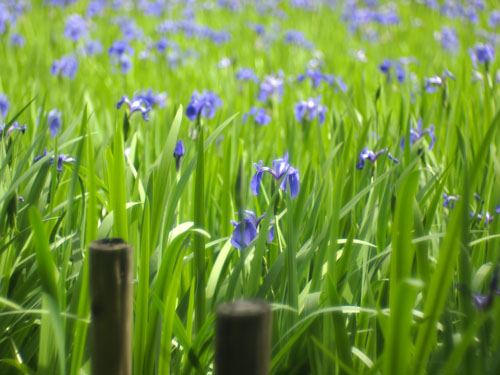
[[250, 152, 300, 199]]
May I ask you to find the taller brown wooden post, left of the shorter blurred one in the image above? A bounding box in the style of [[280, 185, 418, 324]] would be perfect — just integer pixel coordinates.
[[89, 238, 132, 375]]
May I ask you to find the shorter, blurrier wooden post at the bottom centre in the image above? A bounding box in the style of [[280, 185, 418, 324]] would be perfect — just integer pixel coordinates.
[[215, 300, 271, 375]]
